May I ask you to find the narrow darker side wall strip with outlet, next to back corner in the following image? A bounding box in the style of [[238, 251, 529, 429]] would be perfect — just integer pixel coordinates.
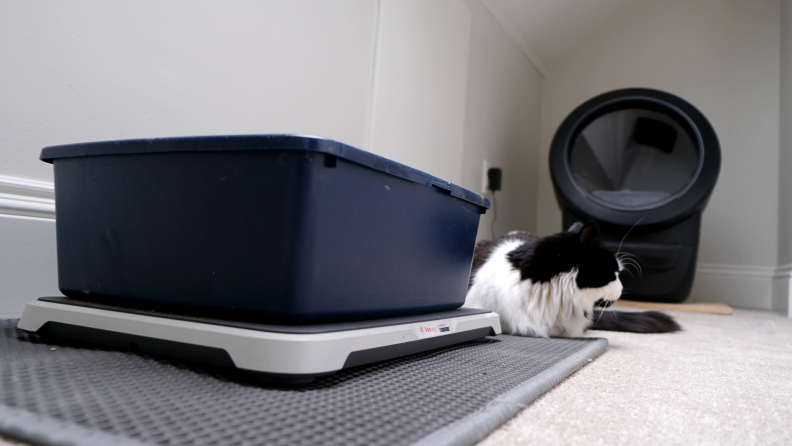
[[461, 0, 542, 238]]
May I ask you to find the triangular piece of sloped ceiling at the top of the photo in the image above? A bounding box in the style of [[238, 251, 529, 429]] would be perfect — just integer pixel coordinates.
[[483, 0, 636, 76]]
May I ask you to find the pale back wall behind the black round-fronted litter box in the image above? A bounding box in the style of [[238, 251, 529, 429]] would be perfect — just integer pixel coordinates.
[[538, 0, 780, 308]]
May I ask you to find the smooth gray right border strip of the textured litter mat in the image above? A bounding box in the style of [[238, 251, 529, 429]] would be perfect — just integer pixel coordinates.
[[412, 338, 608, 446]]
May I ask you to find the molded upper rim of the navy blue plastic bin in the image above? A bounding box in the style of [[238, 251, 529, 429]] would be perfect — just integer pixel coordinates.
[[44, 134, 490, 213]]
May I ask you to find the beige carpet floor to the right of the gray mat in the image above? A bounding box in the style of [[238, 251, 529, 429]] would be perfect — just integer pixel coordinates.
[[0, 309, 792, 446]]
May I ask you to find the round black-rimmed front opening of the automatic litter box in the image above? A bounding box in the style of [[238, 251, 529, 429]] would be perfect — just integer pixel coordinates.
[[550, 88, 720, 226]]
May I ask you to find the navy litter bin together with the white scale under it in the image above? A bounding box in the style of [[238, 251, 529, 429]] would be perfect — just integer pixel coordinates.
[[19, 135, 500, 379]]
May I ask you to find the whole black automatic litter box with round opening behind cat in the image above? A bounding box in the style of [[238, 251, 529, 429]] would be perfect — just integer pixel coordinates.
[[550, 88, 720, 303]]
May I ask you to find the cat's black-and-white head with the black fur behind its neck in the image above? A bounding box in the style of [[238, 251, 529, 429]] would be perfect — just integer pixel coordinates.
[[510, 221, 622, 303]]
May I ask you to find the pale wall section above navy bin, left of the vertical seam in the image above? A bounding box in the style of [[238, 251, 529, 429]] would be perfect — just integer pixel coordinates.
[[0, 0, 377, 180]]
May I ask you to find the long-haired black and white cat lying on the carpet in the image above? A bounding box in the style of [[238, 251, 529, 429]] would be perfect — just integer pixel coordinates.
[[465, 222, 680, 337]]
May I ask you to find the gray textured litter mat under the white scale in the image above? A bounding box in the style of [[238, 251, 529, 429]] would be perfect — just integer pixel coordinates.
[[0, 319, 608, 446]]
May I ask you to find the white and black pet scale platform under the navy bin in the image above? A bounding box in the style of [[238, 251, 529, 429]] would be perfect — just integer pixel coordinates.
[[18, 297, 501, 382]]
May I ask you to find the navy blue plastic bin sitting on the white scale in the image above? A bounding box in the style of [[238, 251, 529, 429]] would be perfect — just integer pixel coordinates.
[[41, 135, 489, 323]]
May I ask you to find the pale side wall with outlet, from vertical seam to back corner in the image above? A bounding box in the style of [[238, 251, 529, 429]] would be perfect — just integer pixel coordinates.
[[369, 0, 542, 220]]
